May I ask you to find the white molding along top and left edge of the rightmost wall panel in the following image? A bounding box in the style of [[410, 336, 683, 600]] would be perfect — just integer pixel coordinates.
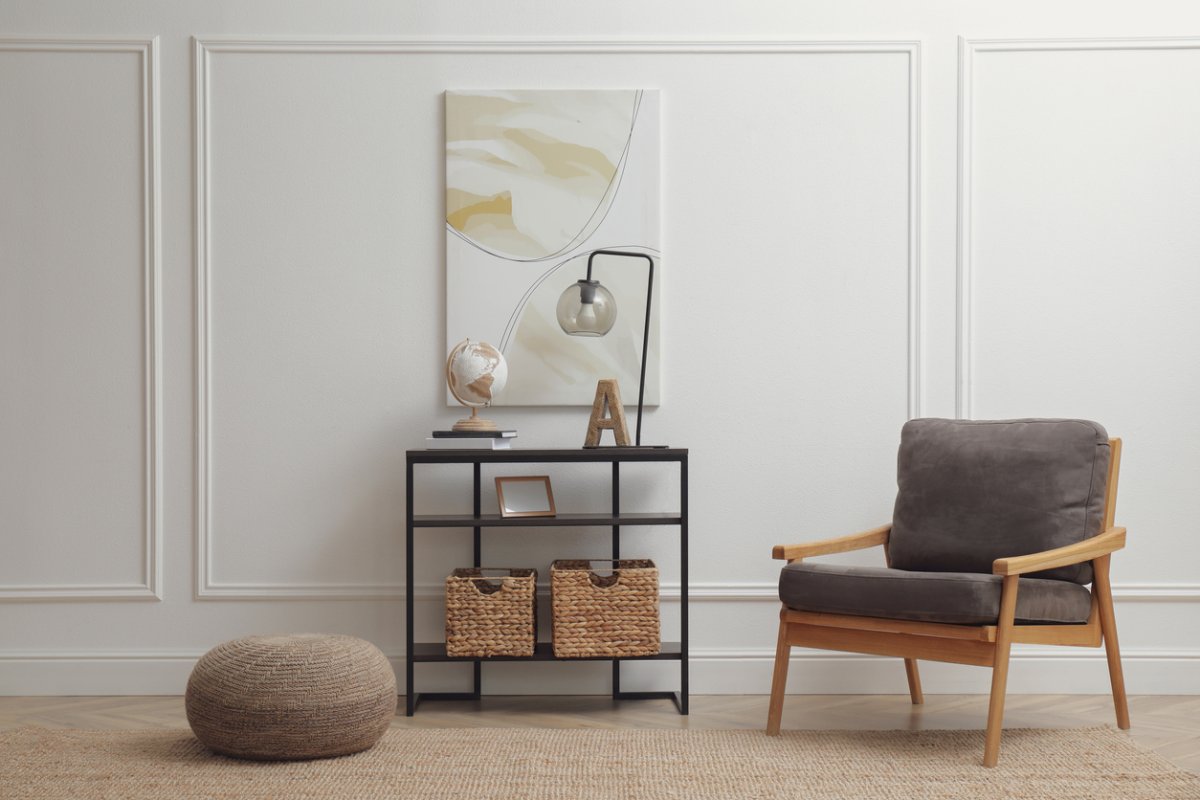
[[954, 37, 1200, 419]]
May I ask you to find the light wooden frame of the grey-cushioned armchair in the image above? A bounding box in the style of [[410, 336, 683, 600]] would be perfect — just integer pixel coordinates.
[[767, 439, 1129, 766]]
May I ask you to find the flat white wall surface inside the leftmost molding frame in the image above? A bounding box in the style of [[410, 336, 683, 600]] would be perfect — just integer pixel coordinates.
[[0, 42, 157, 597]]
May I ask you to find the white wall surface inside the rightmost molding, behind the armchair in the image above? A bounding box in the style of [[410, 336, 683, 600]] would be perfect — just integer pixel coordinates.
[[966, 42, 1200, 587]]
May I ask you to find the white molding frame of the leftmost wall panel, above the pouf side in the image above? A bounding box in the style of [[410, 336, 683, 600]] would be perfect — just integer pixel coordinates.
[[0, 36, 163, 601]]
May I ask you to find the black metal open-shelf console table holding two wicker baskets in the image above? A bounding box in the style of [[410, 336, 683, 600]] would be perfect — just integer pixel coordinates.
[[404, 447, 688, 716]]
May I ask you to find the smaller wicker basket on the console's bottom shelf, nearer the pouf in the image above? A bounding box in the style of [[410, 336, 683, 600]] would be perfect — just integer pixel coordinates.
[[446, 567, 538, 658]]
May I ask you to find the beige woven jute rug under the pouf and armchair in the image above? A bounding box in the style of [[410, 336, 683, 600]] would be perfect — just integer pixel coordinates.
[[0, 728, 1200, 800]]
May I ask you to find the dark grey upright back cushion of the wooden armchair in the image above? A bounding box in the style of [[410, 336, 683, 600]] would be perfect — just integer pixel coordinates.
[[888, 420, 1110, 583]]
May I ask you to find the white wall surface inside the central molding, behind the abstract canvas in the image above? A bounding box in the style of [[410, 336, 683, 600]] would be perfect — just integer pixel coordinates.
[[199, 40, 916, 597]]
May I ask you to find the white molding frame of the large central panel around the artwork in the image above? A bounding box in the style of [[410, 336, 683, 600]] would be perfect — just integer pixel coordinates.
[[192, 36, 924, 601]]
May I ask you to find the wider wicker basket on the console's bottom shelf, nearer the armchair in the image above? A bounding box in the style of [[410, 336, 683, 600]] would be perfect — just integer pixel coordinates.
[[550, 559, 660, 658]]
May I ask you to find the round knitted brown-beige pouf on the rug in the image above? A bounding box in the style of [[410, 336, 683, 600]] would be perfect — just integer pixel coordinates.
[[186, 633, 396, 760]]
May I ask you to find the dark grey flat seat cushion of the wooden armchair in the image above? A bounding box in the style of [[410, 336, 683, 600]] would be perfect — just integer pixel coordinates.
[[779, 563, 1092, 625]]
